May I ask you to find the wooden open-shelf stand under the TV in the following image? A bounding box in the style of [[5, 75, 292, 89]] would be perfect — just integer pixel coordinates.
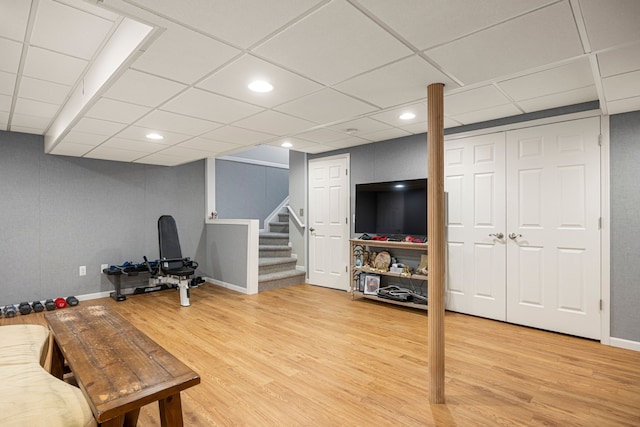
[[349, 239, 429, 310]]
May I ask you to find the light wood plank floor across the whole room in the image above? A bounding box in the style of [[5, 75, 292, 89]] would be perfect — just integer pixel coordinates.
[[0, 284, 640, 427]]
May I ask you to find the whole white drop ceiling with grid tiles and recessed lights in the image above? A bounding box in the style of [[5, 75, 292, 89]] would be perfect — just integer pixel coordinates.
[[0, 0, 640, 166]]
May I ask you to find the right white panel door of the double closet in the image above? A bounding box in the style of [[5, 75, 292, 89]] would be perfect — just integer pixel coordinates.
[[506, 118, 600, 339]]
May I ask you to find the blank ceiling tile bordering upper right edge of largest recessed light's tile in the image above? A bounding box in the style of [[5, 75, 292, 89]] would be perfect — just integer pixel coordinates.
[[256, 0, 413, 84]]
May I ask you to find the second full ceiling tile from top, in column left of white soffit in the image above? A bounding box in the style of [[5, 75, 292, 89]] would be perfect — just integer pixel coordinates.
[[24, 46, 87, 86]]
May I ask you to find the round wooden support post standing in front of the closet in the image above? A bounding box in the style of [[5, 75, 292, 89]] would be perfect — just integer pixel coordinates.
[[427, 83, 445, 403]]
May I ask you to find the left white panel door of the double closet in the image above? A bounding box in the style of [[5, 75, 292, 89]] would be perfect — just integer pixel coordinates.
[[445, 133, 506, 320]]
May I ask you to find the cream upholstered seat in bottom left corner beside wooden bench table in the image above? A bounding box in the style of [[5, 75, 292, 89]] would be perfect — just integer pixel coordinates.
[[0, 325, 97, 427]]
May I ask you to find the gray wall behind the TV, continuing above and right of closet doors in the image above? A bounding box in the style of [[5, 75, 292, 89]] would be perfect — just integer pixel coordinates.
[[300, 101, 640, 342]]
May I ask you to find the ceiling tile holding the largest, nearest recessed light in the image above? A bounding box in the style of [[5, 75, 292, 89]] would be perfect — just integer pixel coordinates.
[[197, 55, 322, 107]]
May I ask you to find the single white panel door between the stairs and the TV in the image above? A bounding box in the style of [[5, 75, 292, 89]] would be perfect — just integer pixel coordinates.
[[309, 156, 349, 291]]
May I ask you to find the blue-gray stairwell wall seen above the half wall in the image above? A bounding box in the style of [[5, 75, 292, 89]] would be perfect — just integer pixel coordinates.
[[216, 159, 289, 228]]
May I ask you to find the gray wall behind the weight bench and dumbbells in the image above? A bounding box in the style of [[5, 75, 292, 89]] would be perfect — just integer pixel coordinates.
[[0, 131, 206, 305]]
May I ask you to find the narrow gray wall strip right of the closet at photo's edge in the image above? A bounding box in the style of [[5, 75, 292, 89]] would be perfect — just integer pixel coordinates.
[[610, 111, 640, 342]]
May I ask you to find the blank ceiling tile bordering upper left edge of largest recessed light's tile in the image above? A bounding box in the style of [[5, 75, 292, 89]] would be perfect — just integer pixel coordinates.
[[133, 25, 240, 84]]
